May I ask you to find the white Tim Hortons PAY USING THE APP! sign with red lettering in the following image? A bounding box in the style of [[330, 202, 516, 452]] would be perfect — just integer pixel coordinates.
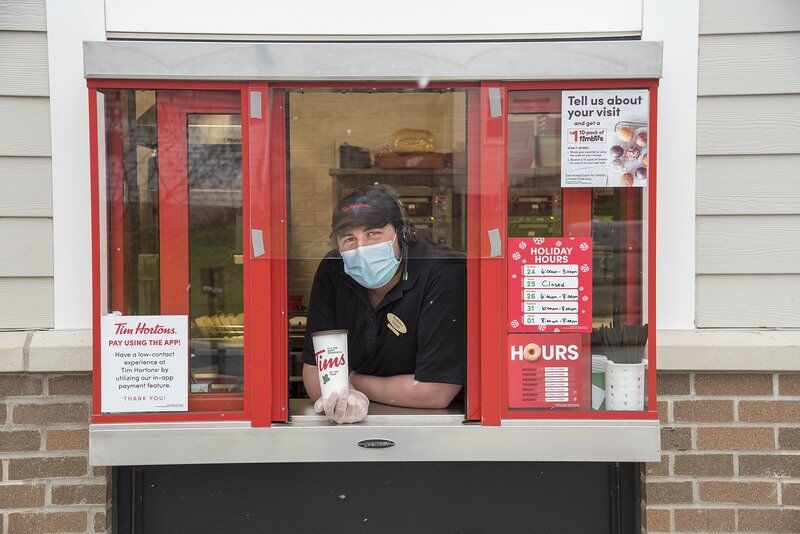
[[100, 315, 189, 413]]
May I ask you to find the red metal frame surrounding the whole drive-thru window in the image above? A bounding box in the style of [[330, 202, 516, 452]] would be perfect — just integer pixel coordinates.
[[87, 79, 658, 426]]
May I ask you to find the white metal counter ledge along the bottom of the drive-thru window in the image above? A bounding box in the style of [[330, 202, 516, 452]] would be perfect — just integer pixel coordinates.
[[89, 400, 661, 466]]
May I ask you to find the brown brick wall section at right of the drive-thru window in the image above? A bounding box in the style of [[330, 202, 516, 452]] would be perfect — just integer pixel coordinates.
[[643, 373, 800, 532]]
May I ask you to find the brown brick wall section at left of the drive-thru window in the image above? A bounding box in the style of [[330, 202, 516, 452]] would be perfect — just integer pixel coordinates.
[[0, 373, 110, 534]]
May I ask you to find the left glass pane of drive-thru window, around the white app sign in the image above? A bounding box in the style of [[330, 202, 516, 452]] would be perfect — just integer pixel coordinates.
[[98, 90, 244, 411]]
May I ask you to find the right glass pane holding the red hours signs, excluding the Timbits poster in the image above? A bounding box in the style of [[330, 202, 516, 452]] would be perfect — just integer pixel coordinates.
[[507, 91, 649, 411]]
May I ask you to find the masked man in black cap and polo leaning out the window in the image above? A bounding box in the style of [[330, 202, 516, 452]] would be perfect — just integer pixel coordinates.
[[303, 185, 466, 423]]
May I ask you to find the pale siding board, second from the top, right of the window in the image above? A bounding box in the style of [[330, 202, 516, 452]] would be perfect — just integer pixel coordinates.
[[697, 32, 800, 95]]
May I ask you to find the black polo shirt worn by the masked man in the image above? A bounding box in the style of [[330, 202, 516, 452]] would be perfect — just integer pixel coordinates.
[[303, 242, 467, 385]]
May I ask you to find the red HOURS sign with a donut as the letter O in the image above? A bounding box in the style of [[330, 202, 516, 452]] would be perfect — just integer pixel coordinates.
[[506, 334, 587, 409]]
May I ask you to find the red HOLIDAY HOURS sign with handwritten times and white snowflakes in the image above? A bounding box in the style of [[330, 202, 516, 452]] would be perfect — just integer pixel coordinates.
[[508, 237, 592, 332]]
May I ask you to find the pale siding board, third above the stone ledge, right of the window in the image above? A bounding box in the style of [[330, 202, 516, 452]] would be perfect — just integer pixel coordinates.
[[697, 154, 800, 215]]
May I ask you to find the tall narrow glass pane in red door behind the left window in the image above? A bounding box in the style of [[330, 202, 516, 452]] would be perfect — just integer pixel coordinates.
[[186, 113, 244, 393]]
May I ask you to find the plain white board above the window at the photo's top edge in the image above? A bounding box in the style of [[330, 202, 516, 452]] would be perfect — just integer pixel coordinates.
[[104, 0, 642, 39]]
